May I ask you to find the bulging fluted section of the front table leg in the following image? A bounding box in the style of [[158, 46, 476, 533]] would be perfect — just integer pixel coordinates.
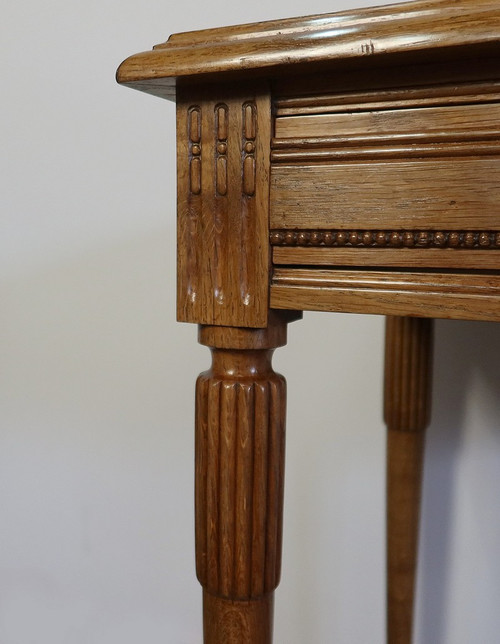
[[196, 358, 285, 600]]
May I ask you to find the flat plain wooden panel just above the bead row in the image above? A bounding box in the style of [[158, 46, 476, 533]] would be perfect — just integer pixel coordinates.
[[271, 158, 500, 230]]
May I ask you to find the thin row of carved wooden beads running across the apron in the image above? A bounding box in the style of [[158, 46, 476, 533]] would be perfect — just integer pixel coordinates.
[[270, 230, 500, 250]]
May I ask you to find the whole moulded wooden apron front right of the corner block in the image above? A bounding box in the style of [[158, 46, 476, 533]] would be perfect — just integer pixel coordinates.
[[270, 82, 500, 320]]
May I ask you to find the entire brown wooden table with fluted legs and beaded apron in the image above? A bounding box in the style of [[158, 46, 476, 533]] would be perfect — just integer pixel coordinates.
[[117, 0, 500, 644]]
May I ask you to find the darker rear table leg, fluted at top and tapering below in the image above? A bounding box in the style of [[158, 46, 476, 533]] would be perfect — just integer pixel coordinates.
[[384, 317, 433, 644]]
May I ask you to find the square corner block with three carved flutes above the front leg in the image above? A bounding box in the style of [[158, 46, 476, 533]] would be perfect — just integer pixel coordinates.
[[177, 85, 271, 328]]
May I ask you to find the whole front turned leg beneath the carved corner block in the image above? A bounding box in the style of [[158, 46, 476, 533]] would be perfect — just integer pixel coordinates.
[[195, 314, 292, 644]]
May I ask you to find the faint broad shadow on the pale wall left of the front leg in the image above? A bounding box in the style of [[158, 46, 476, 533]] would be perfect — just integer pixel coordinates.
[[0, 230, 205, 644]]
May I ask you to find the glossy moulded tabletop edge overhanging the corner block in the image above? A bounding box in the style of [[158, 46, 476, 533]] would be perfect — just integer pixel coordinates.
[[117, 0, 500, 98]]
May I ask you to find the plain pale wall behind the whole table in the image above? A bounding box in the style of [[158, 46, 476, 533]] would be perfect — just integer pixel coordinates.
[[0, 0, 500, 644]]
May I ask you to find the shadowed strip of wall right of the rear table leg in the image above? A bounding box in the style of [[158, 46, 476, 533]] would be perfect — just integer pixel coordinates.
[[417, 320, 500, 644]]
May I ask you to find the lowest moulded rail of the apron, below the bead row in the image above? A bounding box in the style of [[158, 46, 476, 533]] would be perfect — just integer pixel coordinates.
[[271, 268, 500, 321]]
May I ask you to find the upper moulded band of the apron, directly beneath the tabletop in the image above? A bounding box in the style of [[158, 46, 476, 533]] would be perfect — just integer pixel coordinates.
[[271, 81, 500, 164]]
